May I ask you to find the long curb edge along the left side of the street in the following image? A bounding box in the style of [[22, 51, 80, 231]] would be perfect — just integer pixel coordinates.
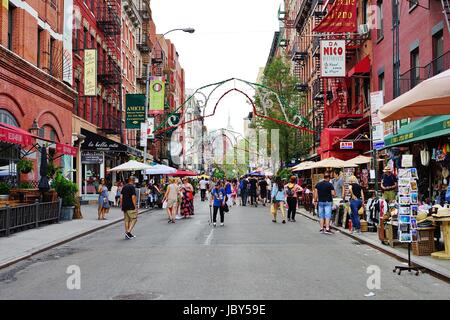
[[0, 209, 153, 270]]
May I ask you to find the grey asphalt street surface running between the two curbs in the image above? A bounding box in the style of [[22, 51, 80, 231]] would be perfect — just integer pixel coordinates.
[[0, 200, 450, 300]]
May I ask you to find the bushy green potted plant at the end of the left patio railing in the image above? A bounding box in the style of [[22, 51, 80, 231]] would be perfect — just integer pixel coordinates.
[[52, 174, 78, 221]]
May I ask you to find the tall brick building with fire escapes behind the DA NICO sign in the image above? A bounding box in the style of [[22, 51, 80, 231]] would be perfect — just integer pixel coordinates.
[[277, 0, 372, 160]]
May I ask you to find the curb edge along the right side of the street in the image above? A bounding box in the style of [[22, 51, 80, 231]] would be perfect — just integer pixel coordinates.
[[297, 211, 450, 283]]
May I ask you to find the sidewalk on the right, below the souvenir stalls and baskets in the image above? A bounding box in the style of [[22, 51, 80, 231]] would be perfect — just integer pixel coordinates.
[[297, 208, 450, 280]]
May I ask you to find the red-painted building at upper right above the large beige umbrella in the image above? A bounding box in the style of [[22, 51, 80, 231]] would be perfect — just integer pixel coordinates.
[[372, 0, 450, 135]]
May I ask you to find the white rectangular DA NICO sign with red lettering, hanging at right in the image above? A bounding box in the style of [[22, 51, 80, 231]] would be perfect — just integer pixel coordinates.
[[320, 40, 346, 78]]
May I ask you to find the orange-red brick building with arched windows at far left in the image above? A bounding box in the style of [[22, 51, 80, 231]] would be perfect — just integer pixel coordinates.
[[0, 0, 74, 181]]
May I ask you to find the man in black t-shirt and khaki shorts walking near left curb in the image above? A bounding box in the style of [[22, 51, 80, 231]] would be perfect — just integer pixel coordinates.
[[120, 176, 138, 239]]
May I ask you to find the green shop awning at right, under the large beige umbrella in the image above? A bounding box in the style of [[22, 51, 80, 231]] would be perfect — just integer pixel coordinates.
[[384, 115, 450, 147]]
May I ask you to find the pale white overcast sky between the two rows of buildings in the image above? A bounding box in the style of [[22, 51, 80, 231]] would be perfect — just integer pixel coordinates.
[[151, 0, 281, 133]]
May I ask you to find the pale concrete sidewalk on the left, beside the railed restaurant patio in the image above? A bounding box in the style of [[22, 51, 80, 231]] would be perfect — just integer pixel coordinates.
[[0, 205, 151, 269]]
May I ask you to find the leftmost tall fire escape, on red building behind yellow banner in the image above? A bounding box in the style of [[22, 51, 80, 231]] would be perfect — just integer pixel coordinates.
[[97, 0, 122, 134]]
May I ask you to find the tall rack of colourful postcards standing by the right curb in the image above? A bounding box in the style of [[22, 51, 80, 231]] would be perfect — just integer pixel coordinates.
[[398, 168, 419, 243]]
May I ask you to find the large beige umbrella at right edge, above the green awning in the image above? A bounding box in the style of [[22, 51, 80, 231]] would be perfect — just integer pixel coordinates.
[[379, 69, 450, 122]]
